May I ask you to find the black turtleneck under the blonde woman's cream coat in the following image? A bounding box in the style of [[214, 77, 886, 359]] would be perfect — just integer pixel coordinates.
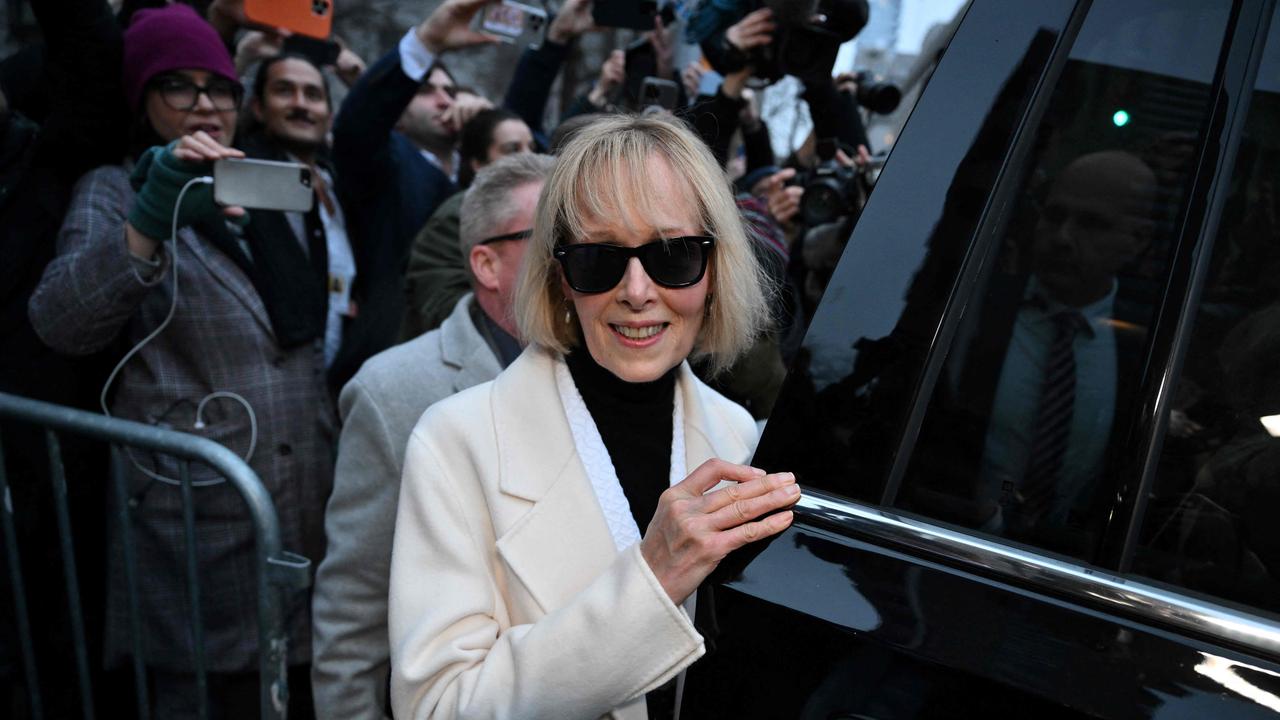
[[564, 347, 678, 536]]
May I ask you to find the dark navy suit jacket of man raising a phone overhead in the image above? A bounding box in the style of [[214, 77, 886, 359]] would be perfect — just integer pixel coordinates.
[[329, 49, 457, 388]]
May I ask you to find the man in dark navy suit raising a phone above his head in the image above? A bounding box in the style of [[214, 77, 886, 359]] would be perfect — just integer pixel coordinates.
[[330, 0, 494, 386]]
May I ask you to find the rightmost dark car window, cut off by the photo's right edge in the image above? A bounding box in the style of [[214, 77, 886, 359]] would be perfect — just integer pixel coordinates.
[[1133, 2, 1280, 611]]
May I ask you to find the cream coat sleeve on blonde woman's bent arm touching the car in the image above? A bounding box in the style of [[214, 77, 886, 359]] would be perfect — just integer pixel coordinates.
[[389, 423, 705, 720]]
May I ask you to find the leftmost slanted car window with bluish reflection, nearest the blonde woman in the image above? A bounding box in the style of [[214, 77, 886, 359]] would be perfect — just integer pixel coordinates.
[[755, 0, 1076, 502]]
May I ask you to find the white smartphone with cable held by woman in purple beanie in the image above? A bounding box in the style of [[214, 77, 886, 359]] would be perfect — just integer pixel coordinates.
[[214, 158, 316, 213]]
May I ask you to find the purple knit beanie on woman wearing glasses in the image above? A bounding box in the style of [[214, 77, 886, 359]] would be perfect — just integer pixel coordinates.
[[124, 3, 239, 110]]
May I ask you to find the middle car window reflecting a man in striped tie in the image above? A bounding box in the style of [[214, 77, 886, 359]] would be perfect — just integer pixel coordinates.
[[895, 0, 1231, 561]]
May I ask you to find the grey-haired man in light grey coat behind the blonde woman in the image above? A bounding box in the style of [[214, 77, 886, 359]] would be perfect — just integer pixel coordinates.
[[312, 152, 554, 719]]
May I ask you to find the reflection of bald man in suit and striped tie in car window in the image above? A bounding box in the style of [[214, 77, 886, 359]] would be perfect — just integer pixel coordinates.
[[915, 151, 1156, 552]]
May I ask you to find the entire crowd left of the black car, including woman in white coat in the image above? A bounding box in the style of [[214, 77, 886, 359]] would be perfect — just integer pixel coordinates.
[[0, 0, 867, 719]]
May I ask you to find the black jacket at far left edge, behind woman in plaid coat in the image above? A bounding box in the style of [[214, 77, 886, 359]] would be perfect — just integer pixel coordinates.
[[0, 0, 127, 405]]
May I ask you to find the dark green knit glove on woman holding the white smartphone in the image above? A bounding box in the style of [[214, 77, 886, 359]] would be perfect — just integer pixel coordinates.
[[129, 141, 248, 240]]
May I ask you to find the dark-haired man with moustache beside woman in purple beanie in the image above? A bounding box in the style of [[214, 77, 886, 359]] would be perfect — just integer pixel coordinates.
[[242, 54, 367, 389]]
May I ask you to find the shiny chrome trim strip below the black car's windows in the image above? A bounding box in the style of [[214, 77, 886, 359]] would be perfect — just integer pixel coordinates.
[[795, 487, 1280, 659]]
